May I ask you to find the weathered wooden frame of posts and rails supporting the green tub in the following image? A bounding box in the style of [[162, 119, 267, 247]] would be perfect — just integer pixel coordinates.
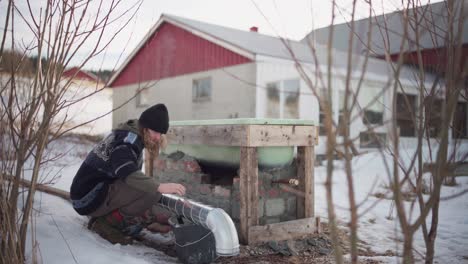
[[167, 124, 319, 244]]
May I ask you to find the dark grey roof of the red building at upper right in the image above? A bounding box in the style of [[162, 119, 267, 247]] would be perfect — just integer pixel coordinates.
[[302, 0, 468, 56]]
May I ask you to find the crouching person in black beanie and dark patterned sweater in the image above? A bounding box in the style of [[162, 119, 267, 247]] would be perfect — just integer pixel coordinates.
[[70, 104, 185, 244]]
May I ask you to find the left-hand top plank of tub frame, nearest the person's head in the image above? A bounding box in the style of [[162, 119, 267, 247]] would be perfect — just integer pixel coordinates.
[[167, 125, 247, 146]]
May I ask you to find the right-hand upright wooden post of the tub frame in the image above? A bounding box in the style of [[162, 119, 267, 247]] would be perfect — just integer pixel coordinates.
[[297, 146, 315, 218]]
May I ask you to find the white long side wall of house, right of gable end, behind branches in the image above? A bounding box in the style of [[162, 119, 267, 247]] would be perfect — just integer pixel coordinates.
[[255, 56, 468, 155]]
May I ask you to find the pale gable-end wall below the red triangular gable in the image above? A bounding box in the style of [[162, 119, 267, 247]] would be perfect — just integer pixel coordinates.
[[113, 63, 256, 127]]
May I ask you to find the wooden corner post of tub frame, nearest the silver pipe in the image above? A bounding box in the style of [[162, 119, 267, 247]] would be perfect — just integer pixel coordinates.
[[239, 147, 258, 244]]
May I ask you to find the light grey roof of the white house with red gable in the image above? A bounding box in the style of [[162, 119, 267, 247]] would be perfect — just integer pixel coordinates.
[[110, 14, 432, 83]]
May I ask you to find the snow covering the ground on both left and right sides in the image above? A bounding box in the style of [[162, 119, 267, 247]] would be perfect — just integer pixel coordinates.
[[21, 82, 468, 263]]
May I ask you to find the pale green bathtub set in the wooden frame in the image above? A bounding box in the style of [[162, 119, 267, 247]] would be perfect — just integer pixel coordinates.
[[163, 118, 314, 167]]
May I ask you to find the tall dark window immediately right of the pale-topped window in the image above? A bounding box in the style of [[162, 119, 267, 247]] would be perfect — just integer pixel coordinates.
[[396, 93, 416, 137]]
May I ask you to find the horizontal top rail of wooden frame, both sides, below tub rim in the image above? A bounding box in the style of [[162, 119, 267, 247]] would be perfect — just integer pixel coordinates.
[[167, 125, 317, 147]]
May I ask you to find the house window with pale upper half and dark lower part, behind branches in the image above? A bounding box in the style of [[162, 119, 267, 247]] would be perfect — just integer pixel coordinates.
[[359, 87, 384, 125]]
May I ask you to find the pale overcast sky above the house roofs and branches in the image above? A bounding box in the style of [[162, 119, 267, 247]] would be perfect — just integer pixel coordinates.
[[0, 0, 435, 70]]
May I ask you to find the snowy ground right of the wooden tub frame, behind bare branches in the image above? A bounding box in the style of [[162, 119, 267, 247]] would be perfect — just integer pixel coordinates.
[[315, 152, 468, 263]]
